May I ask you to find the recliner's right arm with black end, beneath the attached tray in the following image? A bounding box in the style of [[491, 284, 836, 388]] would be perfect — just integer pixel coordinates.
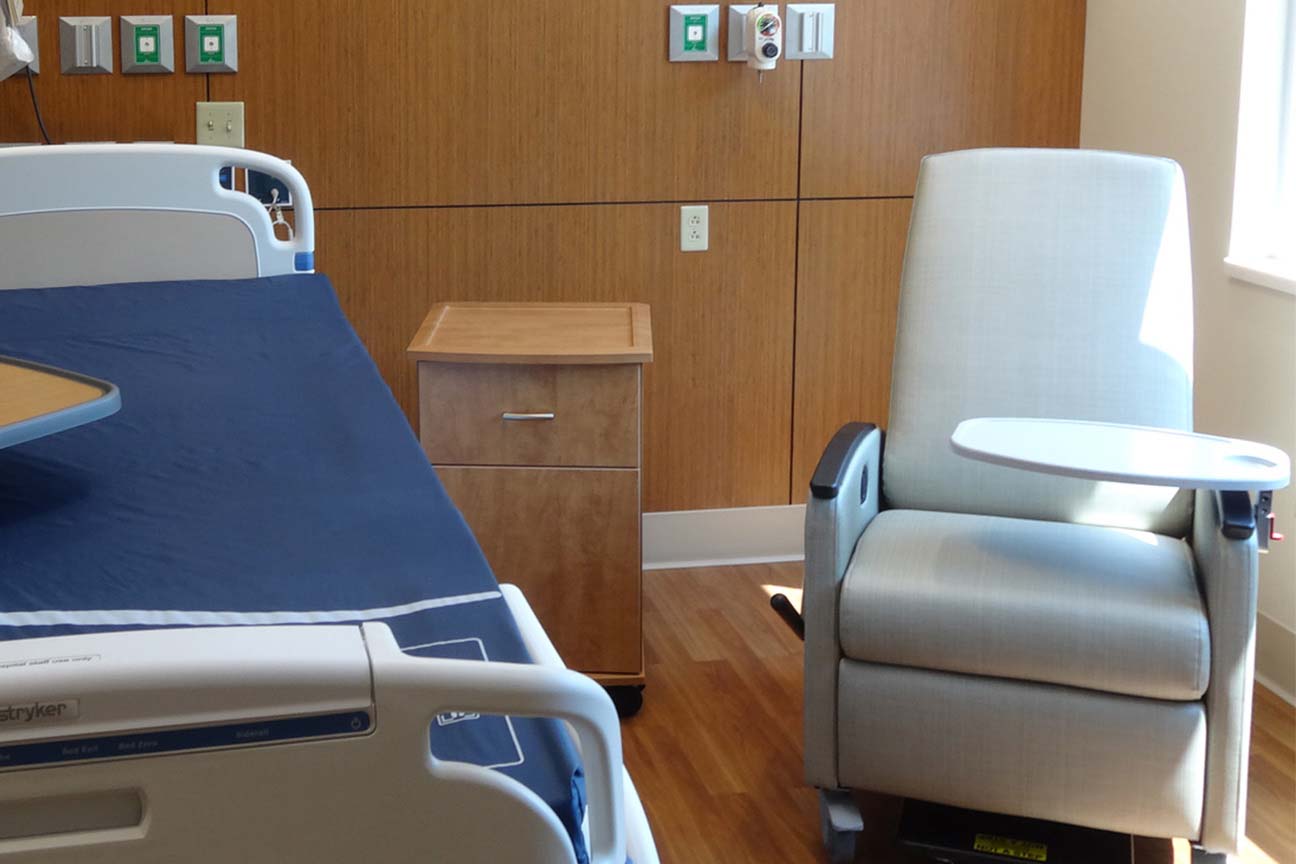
[[1191, 490, 1260, 852]]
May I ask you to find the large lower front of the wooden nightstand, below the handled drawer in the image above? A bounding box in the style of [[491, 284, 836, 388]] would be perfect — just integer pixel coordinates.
[[437, 465, 643, 675]]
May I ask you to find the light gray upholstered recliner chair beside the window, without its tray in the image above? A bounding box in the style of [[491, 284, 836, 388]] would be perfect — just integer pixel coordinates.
[[804, 149, 1257, 855]]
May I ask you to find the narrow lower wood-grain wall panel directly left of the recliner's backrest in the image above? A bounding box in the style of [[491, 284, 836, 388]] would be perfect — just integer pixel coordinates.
[[792, 198, 912, 504]]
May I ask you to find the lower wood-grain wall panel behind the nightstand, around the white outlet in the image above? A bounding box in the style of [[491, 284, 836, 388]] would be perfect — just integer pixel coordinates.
[[318, 202, 796, 510]]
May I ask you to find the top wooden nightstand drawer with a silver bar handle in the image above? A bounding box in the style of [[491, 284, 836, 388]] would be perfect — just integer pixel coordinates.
[[419, 363, 640, 468]]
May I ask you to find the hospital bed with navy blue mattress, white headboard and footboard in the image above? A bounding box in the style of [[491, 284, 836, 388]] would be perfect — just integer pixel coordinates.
[[0, 145, 657, 864]]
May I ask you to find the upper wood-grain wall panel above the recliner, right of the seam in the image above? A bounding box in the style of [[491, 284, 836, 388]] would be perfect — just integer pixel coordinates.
[[801, 0, 1085, 198]]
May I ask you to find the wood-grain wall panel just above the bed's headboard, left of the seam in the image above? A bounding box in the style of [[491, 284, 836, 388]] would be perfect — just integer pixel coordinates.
[[0, 0, 207, 144]]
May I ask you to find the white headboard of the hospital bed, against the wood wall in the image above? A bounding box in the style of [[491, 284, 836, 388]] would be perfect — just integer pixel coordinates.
[[0, 144, 315, 290]]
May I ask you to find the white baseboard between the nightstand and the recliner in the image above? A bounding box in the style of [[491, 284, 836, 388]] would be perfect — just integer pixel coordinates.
[[644, 504, 806, 570]]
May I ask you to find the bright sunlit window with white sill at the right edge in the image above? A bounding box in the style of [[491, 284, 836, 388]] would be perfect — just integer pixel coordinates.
[[1225, 0, 1296, 294]]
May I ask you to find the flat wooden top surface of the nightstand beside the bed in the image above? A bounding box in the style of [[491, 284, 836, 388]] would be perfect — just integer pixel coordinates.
[[406, 303, 652, 364]]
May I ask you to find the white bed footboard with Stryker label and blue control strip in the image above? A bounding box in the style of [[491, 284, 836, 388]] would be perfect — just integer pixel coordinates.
[[0, 623, 627, 864]]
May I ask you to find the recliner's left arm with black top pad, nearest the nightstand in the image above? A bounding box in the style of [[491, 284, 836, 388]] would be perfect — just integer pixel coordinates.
[[801, 424, 883, 789]]
